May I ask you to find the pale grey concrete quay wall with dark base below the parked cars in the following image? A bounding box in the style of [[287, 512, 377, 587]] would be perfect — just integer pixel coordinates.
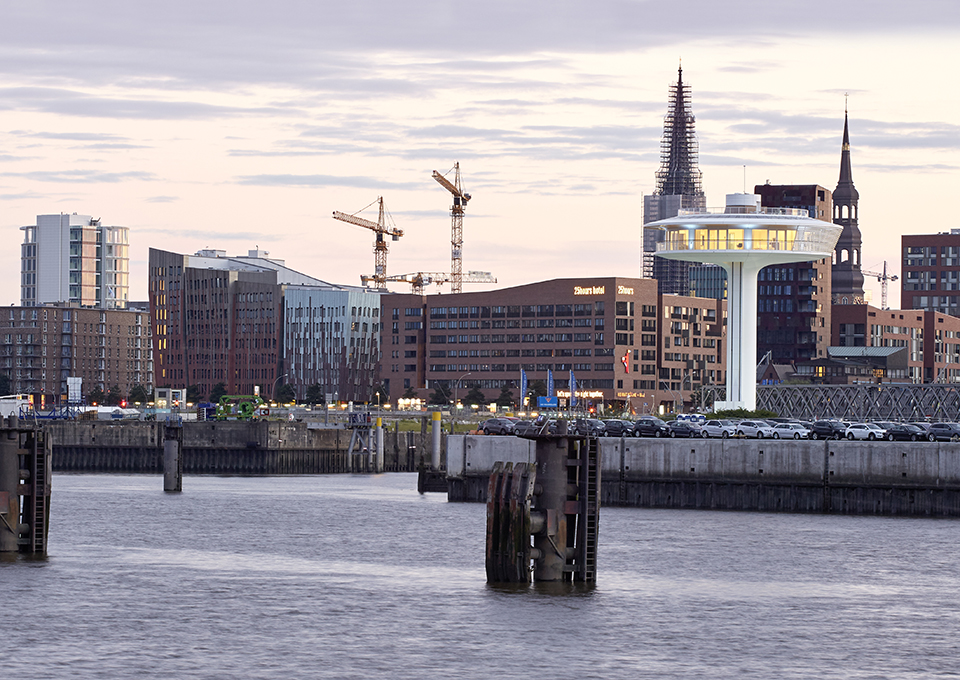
[[447, 435, 960, 517]]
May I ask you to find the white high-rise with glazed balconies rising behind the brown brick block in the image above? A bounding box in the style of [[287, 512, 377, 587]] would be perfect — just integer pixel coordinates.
[[20, 213, 130, 309]]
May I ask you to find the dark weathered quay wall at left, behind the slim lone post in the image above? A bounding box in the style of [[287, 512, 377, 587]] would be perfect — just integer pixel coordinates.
[[43, 421, 436, 475]]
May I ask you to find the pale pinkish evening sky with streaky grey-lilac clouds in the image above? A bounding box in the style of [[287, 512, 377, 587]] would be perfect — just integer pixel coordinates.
[[0, 0, 960, 307]]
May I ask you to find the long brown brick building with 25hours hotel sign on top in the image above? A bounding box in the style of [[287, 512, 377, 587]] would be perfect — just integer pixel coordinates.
[[381, 277, 726, 412]]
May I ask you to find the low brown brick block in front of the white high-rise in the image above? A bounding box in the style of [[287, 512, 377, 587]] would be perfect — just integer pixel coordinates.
[[0, 305, 154, 404]]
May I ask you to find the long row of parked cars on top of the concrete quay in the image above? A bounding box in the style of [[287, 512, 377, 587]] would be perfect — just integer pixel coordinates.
[[478, 416, 960, 442]]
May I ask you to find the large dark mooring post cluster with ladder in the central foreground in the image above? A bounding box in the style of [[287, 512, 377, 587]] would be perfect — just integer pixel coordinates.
[[486, 419, 600, 583]]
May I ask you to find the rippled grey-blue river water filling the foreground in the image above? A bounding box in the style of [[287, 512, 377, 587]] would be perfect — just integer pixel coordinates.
[[0, 474, 960, 680]]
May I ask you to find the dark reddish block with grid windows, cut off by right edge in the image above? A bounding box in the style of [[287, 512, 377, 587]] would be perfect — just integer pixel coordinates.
[[900, 229, 960, 316]]
